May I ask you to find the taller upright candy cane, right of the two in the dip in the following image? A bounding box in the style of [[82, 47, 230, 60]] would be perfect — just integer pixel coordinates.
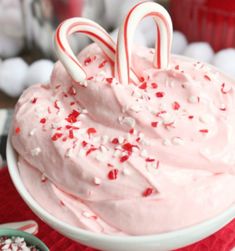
[[115, 2, 172, 83]]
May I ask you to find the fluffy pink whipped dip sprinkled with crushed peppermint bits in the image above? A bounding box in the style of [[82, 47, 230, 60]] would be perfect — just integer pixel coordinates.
[[12, 44, 235, 235]]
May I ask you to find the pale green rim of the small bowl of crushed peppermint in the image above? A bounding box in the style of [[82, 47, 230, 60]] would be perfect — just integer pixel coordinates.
[[0, 228, 49, 251]]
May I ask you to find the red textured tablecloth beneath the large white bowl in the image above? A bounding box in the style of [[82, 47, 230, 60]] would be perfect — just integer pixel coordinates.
[[0, 168, 235, 251]]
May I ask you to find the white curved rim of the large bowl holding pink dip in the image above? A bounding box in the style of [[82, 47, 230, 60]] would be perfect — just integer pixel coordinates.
[[6, 133, 235, 244]]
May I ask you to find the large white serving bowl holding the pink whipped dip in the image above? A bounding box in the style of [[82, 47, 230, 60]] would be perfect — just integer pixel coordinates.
[[7, 134, 235, 251]]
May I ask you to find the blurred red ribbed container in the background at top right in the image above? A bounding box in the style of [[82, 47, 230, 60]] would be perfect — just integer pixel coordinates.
[[170, 0, 235, 51]]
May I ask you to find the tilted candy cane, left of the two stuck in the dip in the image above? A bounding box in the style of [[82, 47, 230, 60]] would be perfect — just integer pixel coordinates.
[[54, 17, 116, 82]]
